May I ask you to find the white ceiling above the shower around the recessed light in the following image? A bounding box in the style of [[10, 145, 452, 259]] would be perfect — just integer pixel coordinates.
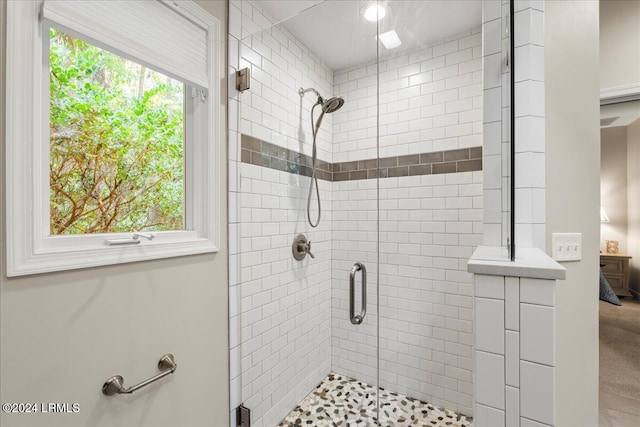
[[256, 0, 482, 70]]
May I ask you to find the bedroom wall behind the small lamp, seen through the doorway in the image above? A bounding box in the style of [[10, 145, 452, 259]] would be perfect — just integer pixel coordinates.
[[600, 127, 636, 253]]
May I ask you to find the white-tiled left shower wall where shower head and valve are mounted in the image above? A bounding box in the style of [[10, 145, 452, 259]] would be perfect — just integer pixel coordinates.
[[229, 1, 333, 427]]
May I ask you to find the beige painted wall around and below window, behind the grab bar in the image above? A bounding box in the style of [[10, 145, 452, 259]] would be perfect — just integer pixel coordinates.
[[0, 1, 229, 427]]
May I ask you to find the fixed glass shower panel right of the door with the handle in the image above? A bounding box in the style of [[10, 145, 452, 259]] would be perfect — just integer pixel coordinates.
[[378, 1, 483, 426]]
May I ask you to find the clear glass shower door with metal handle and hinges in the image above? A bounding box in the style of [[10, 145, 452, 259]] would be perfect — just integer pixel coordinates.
[[229, 1, 378, 427]]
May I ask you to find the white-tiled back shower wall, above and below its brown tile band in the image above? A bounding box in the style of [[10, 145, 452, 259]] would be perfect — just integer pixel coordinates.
[[331, 28, 483, 414]]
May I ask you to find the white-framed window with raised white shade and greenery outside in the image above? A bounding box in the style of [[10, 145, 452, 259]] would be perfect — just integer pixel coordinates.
[[6, 0, 221, 276]]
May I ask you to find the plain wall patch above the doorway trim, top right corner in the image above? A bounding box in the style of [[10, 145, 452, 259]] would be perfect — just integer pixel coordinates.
[[599, 0, 640, 89]]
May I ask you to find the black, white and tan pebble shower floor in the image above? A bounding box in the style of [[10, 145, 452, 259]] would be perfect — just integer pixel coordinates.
[[278, 372, 472, 427]]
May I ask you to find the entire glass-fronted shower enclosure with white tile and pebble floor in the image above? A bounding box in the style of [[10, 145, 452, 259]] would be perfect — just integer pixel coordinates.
[[229, 0, 509, 427]]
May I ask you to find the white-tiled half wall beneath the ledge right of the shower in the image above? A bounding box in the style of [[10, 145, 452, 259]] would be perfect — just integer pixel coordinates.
[[474, 274, 556, 427]]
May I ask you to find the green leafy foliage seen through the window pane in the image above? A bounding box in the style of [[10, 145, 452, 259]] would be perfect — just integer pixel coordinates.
[[49, 30, 184, 235]]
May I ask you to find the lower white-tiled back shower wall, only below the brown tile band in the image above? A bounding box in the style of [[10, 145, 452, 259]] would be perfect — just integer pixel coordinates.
[[331, 171, 482, 414]]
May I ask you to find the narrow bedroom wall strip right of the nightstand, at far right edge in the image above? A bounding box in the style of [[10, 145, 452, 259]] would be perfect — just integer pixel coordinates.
[[627, 119, 640, 297]]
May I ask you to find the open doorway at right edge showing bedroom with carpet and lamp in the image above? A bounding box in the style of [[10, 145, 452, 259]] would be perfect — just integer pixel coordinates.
[[599, 1, 640, 427]]
